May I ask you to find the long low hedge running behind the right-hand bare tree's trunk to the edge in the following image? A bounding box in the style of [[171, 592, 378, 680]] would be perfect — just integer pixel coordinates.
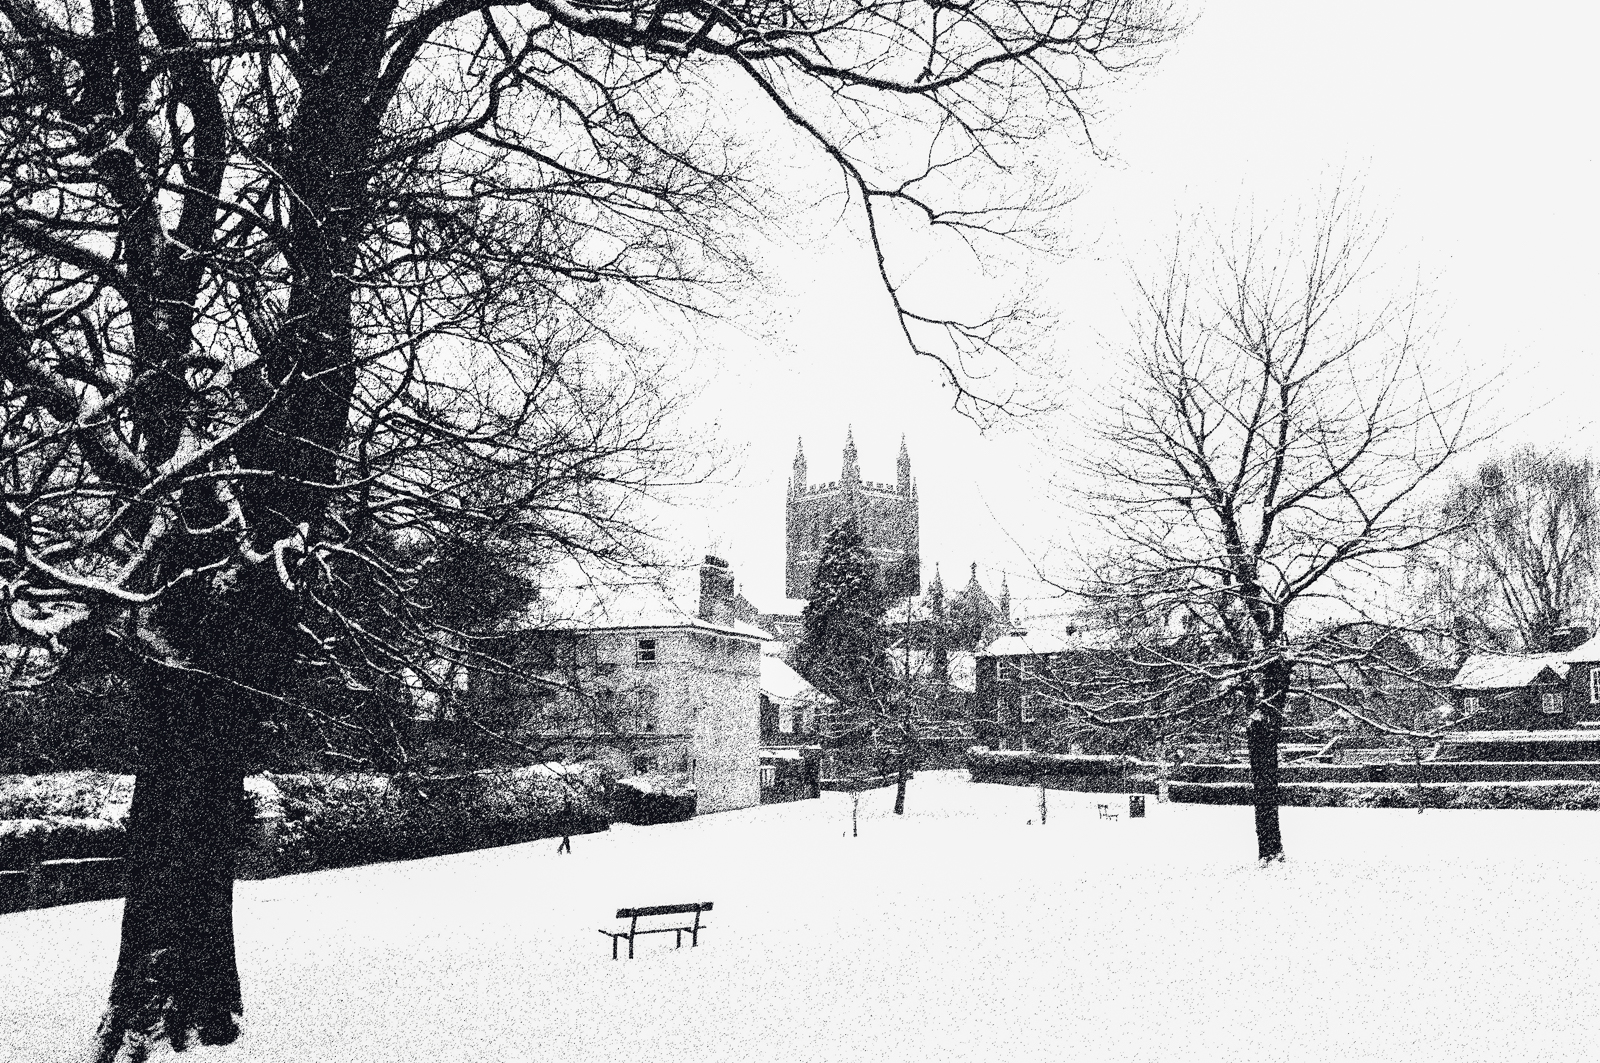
[[1166, 781, 1600, 810]]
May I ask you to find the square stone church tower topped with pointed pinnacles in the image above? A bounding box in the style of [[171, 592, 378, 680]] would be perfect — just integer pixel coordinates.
[[784, 431, 922, 599]]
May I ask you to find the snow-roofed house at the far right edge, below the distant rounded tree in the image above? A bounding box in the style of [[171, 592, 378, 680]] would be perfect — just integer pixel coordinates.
[[1450, 628, 1600, 730]]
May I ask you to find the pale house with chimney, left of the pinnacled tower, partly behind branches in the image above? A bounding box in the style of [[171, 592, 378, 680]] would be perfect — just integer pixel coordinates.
[[470, 557, 766, 812]]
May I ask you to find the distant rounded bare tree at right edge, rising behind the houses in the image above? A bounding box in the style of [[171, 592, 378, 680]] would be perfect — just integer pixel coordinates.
[[1414, 447, 1600, 653]]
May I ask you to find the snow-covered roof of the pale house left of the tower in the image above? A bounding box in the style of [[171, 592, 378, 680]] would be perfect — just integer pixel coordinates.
[[518, 565, 771, 640]]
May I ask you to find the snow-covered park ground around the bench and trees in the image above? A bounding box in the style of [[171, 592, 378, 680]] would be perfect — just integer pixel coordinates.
[[0, 772, 1600, 1063]]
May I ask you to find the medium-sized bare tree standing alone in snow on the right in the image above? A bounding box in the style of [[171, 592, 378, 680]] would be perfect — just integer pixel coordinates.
[[1082, 191, 1467, 861]]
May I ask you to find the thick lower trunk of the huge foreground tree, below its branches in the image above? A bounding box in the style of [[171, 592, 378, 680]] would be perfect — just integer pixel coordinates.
[[94, 684, 243, 1063]]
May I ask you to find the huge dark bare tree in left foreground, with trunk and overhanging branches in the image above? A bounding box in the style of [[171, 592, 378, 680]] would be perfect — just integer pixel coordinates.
[[0, 0, 1173, 1058]]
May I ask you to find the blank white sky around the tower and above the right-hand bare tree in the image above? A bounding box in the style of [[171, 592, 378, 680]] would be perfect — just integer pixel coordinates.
[[656, 0, 1600, 612]]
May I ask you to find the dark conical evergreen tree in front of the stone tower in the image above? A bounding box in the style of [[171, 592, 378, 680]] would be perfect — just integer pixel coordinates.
[[797, 520, 890, 744]]
